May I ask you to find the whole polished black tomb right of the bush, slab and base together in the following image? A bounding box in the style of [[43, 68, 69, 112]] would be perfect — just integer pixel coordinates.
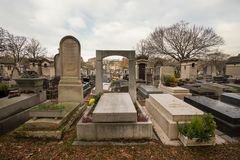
[[184, 96, 240, 136]]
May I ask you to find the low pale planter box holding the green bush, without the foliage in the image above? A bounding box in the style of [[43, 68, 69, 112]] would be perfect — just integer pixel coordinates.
[[178, 133, 216, 146]]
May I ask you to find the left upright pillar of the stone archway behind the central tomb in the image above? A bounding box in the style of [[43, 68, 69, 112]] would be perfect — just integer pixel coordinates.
[[96, 59, 103, 94]]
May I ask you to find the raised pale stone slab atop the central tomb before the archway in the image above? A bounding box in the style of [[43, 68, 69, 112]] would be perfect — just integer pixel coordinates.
[[93, 93, 137, 122]]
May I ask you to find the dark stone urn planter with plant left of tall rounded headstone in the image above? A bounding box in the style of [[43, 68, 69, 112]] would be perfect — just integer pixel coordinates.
[[14, 71, 44, 93]]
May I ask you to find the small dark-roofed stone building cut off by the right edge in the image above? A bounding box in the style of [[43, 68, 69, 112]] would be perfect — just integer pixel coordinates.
[[225, 54, 240, 79]]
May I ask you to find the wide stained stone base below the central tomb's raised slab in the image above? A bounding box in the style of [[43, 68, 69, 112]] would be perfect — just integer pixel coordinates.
[[77, 104, 153, 141]]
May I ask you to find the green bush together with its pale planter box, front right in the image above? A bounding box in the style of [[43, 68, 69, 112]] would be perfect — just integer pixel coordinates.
[[178, 114, 216, 146]]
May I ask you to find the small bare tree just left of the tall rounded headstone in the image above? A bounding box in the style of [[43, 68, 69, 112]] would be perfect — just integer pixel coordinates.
[[27, 38, 47, 59]]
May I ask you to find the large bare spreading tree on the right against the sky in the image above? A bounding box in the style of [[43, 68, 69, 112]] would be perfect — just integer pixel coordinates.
[[147, 21, 224, 62]]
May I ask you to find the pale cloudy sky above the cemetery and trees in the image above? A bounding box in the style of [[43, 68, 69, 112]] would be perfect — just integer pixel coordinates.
[[0, 0, 240, 60]]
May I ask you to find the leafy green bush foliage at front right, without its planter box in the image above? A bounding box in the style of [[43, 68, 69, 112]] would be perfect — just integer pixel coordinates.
[[178, 113, 216, 141]]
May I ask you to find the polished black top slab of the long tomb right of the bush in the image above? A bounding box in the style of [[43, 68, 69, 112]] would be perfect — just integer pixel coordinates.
[[184, 96, 240, 124]]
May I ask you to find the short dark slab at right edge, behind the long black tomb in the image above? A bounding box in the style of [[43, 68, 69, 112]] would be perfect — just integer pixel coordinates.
[[221, 93, 240, 107]]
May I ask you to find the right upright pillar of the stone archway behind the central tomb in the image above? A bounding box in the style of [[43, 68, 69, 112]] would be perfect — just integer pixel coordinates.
[[128, 58, 136, 103]]
